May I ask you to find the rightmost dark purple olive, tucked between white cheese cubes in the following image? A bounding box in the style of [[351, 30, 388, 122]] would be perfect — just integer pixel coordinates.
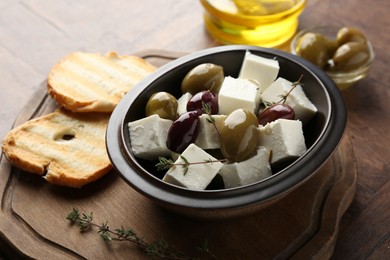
[[257, 104, 295, 125]]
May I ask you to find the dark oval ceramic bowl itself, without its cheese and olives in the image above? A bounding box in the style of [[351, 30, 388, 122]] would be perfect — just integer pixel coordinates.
[[106, 45, 346, 217]]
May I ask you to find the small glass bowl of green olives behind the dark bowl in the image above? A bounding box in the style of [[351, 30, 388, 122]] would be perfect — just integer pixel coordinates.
[[290, 26, 375, 89]]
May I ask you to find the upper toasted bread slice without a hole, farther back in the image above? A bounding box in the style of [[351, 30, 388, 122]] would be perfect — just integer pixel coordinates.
[[48, 52, 156, 112]]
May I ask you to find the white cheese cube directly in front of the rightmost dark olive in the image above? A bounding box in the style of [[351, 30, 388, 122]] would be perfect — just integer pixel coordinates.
[[259, 119, 307, 164]]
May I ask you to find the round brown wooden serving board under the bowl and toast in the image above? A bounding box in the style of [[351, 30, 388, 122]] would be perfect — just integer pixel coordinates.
[[0, 50, 357, 259]]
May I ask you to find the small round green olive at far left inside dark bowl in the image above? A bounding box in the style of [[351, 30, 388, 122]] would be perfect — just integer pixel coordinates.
[[145, 91, 178, 121]]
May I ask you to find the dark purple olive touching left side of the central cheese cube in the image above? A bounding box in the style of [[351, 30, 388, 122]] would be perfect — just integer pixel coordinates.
[[187, 90, 218, 115]]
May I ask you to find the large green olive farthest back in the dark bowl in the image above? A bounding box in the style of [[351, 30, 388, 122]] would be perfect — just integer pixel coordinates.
[[181, 63, 225, 95]]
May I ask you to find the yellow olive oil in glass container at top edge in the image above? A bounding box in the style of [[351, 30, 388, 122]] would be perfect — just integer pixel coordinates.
[[200, 0, 306, 48]]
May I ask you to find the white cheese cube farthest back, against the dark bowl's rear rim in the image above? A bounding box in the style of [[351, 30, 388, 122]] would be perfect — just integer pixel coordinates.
[[238, 51, 279, 93]]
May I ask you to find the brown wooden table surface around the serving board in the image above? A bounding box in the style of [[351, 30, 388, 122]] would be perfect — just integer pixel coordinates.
[[0, 0, 390, 259]]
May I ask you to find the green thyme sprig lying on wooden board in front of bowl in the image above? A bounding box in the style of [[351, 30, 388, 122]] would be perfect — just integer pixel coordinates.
[[66, 208, 217, 259]]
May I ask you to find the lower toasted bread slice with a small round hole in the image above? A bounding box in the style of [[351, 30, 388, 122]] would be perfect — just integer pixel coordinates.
[[2, 109, 112, 187]]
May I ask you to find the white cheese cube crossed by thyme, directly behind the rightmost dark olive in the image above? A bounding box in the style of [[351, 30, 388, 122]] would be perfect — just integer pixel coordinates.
[[261, 78, 317, 124]]
